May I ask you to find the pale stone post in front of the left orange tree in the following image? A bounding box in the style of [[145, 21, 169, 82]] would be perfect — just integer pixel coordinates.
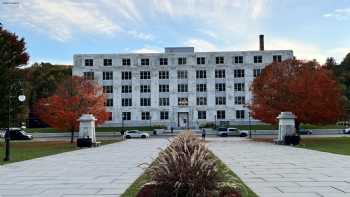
[[78, 114, 96, 144]]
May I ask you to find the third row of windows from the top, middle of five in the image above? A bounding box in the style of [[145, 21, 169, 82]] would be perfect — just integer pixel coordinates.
[[103, 83, 245, 94]]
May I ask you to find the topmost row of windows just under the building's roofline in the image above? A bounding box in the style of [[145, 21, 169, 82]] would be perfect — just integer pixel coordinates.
[[84, 55, 282, 66]]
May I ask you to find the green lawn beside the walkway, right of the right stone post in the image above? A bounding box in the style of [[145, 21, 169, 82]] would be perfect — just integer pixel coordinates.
[[298, 137, 350, 155]]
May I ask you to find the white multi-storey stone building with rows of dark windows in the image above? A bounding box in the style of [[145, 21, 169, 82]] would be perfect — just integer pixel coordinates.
[[73, 37, 293, 128]]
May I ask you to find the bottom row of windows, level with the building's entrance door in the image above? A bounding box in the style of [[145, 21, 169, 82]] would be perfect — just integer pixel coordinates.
[[109, 110, 245, 120]]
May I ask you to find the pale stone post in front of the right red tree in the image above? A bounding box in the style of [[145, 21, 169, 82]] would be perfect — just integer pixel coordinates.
[[277, 112, 296, 144]]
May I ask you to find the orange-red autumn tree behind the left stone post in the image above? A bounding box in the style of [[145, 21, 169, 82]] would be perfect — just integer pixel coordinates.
[[34, 76, 108, 143]]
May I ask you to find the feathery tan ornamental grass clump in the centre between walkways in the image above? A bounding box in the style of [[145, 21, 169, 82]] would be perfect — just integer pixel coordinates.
[[150, 132, 222, 197]]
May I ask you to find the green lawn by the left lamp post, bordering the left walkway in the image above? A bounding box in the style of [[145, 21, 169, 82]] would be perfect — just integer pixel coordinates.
[[0, 140, 118, 165]]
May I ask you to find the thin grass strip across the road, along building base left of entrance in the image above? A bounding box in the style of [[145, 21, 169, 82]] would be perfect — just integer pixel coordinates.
[[26, 126, 164, 133]]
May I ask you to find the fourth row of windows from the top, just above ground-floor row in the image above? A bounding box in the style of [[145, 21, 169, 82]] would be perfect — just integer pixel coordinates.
[[105, 96, 245, 107]]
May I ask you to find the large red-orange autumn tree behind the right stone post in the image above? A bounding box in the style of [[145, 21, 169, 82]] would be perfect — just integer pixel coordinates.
[[250, 60, 343, 129]]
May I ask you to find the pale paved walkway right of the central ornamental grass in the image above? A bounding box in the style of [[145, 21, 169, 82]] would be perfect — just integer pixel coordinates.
[[209, 138, 350, 197]]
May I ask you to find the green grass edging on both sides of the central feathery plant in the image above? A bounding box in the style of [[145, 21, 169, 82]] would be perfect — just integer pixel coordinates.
[[121, 154, 257, 197]]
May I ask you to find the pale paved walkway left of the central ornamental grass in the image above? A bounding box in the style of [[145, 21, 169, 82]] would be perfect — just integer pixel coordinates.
[[0, 139, 168, 197]]
